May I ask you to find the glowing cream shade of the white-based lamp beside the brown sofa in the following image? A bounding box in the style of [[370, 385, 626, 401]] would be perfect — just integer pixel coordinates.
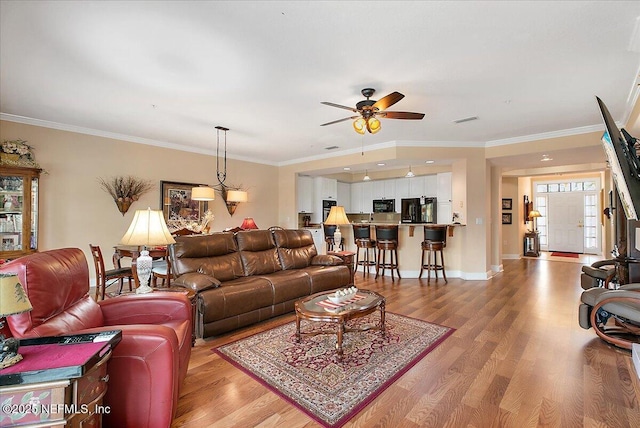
[[120, 208, 176, 246]]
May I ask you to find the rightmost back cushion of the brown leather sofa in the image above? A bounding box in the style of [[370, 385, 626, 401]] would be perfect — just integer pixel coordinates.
[[273, 229, 318, 270]]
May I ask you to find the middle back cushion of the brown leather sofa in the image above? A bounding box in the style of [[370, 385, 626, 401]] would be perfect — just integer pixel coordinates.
[[236, 230, 282, 276]]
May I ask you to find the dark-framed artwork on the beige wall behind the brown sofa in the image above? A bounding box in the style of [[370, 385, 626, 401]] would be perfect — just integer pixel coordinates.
[[160, 181, 209, 229]]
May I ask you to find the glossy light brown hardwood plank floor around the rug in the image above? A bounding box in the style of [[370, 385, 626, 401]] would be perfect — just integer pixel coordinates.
[[173, 259, 640, 428]]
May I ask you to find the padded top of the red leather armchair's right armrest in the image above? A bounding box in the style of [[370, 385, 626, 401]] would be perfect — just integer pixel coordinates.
[[98, 292, 192, 325]]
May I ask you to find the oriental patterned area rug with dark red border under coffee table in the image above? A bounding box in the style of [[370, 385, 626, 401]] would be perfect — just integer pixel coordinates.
[[214, 312, 455, 428]]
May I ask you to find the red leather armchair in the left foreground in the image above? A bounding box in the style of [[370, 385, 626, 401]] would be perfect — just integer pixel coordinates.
[[0, 248, 192, 428]]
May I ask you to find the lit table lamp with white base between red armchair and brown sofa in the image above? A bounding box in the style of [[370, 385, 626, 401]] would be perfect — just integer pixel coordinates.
[[120, 208, 176, 294]]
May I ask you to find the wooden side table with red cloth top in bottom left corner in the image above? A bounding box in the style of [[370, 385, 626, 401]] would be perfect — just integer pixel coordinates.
[[0, 330, 122, 427]]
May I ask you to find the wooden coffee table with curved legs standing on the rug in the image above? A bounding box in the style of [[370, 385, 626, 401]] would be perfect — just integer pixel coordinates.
[[295, 290, 386, 358]]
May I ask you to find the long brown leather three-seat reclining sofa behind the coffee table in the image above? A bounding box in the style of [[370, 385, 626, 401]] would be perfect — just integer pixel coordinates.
[[170, 229, 353, 337]]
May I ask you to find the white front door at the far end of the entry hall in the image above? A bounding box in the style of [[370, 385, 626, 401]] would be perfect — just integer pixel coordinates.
[[547, 192, 584, 253]]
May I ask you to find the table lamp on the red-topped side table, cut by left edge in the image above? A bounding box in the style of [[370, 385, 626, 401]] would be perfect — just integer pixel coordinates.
[[0, 273, 32, 369]]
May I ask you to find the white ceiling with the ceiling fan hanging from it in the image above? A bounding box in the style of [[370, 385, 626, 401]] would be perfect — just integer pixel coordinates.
[[0, 0, 640, 174]]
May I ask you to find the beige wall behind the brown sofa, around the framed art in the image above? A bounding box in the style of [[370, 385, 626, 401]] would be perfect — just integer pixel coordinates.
[[0, 121, 280, 275]]
